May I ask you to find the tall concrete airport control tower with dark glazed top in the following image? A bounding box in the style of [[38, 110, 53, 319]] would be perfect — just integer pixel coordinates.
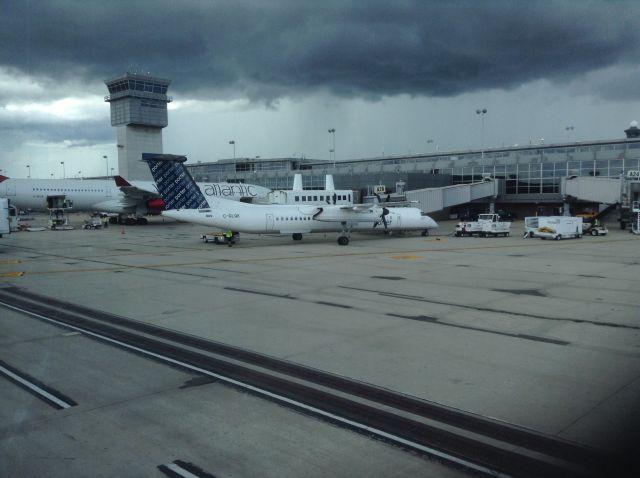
[[104, 72, 171, 181]]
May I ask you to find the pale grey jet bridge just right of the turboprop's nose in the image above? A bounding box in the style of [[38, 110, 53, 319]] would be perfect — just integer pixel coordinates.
[[406, 179, 501, 213]]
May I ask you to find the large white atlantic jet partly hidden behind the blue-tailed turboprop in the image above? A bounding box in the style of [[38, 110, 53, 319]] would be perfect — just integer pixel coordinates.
[[0, 175, 271, 224]]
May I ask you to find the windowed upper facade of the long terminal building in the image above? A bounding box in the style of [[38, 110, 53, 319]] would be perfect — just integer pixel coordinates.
[[189, 138, 640, 199]]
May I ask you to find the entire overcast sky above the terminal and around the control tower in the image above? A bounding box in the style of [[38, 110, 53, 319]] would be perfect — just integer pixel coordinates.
[[0, 0, 640, 177]]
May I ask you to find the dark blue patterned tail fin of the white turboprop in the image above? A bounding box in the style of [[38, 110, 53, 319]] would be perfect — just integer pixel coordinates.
[[142, 153, 209, 210]]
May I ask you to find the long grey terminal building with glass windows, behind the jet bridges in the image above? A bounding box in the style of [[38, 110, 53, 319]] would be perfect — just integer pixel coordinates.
[[188, 128, 640, 221]]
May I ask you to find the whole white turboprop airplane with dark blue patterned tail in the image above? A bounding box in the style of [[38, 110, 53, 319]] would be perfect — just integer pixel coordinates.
[[142, 154, 438, 246]]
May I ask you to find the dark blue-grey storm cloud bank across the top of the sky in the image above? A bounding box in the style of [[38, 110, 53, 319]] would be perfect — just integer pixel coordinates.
[[0, 0, 640, 101]]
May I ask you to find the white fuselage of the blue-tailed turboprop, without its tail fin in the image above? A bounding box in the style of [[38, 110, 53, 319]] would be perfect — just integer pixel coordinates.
[[162, 200, 438, 234]]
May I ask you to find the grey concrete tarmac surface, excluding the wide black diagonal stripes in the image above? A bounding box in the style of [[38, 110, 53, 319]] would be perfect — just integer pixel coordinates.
[[0, 215, 640, 477]]
